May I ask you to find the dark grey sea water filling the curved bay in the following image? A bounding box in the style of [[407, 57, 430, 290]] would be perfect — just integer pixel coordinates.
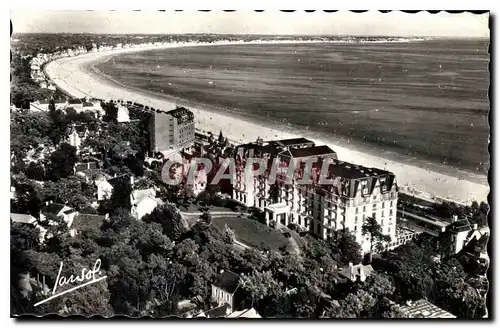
[[96, 39, 490, 175]]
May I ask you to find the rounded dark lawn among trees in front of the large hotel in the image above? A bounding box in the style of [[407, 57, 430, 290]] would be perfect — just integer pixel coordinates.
[[212, 216, 290, 251]]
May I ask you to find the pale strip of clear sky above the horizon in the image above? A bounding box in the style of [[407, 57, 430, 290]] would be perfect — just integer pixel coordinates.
[[11, 10, 489, 37]]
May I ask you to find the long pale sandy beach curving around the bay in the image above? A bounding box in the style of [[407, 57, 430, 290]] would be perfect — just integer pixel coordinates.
[[45, 43, 489, 203]]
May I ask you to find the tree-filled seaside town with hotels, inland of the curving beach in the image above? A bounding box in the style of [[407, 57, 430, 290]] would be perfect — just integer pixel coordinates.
[[10, 35, 490, 318]]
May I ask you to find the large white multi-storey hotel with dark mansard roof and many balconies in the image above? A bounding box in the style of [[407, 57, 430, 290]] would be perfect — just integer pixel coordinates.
[[233, 138, 398, 253]]
